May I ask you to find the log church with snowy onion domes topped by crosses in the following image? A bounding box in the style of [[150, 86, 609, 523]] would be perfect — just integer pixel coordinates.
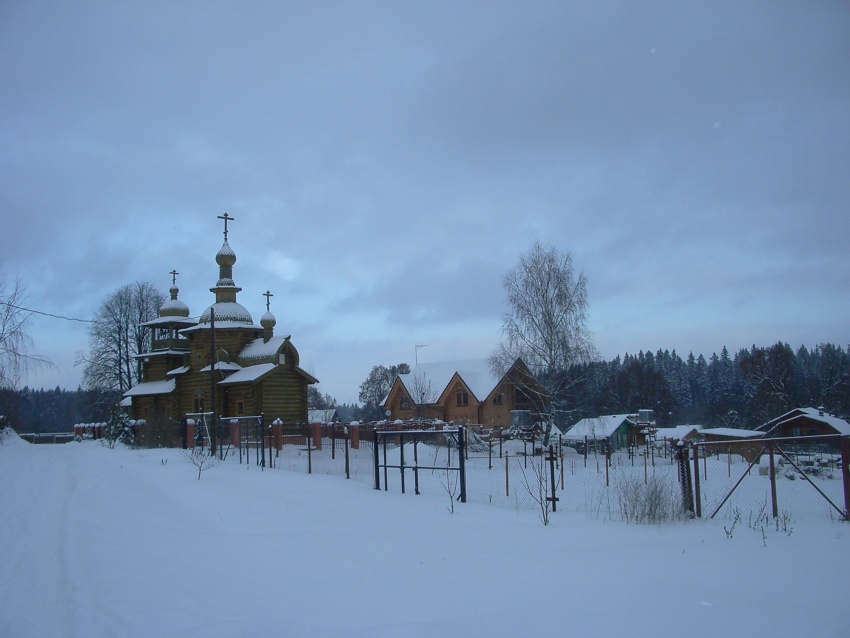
[[124, 213, 318, 424]]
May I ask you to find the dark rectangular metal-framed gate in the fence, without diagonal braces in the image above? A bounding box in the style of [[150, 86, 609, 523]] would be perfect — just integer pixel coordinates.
[[374, 427, 466, 503]]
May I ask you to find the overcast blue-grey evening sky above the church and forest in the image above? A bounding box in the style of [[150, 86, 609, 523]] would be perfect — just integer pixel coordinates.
[[0, 0, 850, 402]]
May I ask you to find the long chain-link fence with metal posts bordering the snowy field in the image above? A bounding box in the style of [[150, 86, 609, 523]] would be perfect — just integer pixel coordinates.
[[127, 417, 850, 522]]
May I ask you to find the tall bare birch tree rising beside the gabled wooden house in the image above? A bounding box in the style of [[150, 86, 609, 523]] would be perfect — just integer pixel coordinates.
[[490, 242, 595, 442]]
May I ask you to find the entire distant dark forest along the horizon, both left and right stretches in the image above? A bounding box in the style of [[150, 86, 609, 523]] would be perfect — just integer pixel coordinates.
[[0, 343, 850, 432]]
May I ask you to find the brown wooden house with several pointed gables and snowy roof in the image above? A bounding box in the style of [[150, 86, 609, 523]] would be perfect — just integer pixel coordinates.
[[381, 359, 542, 428]]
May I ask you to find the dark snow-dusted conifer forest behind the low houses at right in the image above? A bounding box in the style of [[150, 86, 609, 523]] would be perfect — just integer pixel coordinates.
[[562, 343, 850, 428]]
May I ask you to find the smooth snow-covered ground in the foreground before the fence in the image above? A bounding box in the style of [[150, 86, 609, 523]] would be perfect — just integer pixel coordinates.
[[0, 438, 850, 638]]
